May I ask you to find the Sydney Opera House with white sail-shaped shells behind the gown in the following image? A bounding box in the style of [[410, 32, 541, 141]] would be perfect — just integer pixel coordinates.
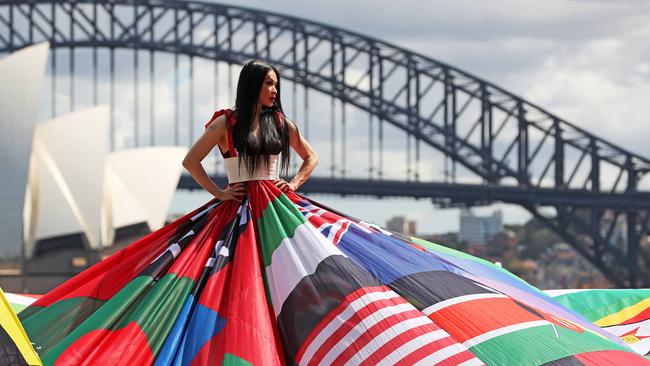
[[0, 42, 186, 293]]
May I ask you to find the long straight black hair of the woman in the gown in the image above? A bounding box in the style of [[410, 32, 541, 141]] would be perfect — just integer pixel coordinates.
[[232, 59, 291, 175]]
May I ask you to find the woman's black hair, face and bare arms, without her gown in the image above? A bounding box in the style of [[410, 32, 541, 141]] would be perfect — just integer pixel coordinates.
[[183, 60, 318, 201]]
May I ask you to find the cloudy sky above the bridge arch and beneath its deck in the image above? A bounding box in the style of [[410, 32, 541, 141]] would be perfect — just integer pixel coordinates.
[[166, 0, 650, 233]]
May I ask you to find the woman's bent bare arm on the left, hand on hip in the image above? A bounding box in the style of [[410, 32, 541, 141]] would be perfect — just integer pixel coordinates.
[[183, 115, 244, 200]]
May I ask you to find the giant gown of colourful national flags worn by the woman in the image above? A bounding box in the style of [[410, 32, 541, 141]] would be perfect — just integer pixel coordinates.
[[19, 109, 650, 366]]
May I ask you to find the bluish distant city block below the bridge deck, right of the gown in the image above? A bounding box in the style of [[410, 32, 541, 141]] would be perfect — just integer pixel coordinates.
[[458, 210, 503, 245]]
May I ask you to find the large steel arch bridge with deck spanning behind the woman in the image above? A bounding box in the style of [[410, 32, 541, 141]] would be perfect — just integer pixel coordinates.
[[0, 0, 650, 287]]
